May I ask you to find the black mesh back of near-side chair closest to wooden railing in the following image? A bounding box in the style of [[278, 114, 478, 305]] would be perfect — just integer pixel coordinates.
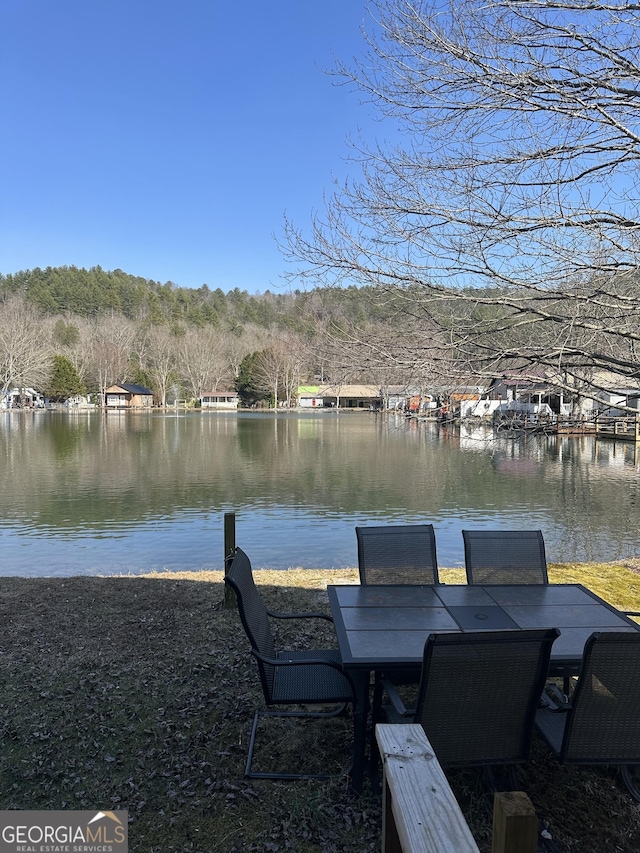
[[415, 628, 556, 766]]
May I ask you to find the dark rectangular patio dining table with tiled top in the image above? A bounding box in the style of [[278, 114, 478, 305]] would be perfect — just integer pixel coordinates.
[[327, 584, 640, 792]]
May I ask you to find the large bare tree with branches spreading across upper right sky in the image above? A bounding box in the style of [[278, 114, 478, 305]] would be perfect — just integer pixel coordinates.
[[285, 0, 640, 406]]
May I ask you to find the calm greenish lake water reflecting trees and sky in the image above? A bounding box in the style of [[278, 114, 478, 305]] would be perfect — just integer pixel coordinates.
[[0, 412, 640, 576]]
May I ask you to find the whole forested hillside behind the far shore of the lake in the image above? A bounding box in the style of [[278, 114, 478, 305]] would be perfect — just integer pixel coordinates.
[[0, 266, 640, 406]]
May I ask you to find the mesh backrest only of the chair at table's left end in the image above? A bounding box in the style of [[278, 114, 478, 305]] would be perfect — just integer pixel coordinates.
[[224, 548, 276, 703]]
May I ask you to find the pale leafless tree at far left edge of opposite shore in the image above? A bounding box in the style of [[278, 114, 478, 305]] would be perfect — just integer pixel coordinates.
[[0, 295, 51, 397]]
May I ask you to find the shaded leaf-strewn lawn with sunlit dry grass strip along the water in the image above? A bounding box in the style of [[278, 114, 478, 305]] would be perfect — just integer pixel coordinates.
[[0, 565, 640, 853]]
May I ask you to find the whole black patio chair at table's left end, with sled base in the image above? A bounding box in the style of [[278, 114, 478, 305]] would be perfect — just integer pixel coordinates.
[[224, 548, 356, 779]]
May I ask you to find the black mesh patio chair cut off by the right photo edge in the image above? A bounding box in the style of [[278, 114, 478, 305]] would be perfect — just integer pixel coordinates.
[[536, 631, 640, 802]]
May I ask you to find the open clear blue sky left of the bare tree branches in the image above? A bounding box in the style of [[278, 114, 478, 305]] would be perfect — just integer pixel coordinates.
[[0, 0, 380, 292]]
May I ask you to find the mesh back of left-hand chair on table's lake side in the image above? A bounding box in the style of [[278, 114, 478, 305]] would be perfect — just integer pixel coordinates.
[[356, 524, 439, 584]]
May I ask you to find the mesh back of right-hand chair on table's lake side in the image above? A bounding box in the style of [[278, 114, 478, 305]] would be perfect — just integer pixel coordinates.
[[462, 530, 549, 584]]
